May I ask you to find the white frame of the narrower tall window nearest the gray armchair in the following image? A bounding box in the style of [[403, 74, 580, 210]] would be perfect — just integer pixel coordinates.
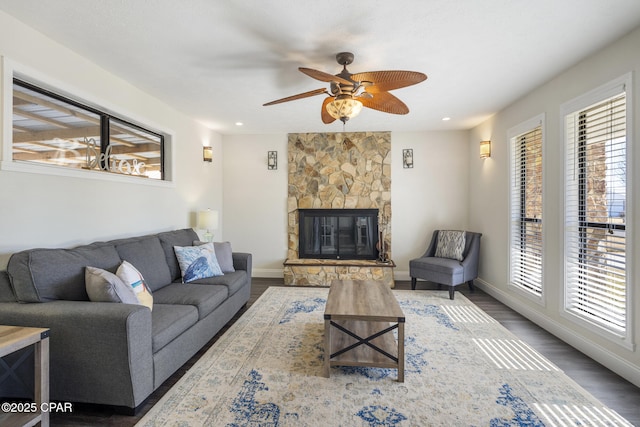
[[507, 113, 546, 307]]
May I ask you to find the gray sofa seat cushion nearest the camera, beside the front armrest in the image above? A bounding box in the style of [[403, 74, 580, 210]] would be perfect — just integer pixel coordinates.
[[151, 304, 198, 354]]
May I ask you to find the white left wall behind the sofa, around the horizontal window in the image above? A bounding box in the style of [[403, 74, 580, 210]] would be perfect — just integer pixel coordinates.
[[0, 12, 223, 268]]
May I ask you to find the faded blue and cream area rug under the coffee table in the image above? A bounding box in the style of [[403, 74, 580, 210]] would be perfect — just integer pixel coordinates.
[[138, 287, 631, 427]]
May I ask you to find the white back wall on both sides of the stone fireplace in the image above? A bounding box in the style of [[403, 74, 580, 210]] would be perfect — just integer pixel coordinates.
[[223, 131, 470, 280]]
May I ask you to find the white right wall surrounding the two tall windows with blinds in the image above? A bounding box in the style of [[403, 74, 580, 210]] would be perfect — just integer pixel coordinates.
[[469, 25, 640, 385]]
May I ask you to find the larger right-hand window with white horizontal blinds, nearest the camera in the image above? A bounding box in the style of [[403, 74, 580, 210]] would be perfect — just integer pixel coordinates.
[[565, 91, 628, 336]]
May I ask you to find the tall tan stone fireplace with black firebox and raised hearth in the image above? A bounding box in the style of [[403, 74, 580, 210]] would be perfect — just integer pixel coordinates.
[[284, 132, 395, 286]]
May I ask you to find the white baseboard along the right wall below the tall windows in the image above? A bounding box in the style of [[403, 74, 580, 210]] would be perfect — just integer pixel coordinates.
[[474, 279, 640, 387]]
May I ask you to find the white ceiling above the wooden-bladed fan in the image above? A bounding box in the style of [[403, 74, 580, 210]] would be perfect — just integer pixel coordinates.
[[0, 0, 640, 134]]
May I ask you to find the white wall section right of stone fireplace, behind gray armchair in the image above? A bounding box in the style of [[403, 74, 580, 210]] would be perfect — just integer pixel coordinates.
[[391, 131, 470, 280]]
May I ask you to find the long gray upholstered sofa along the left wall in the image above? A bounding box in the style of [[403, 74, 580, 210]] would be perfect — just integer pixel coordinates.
[[0, 229, 252, 412]]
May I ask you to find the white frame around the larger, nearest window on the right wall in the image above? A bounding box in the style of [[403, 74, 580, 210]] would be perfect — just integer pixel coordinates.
[[560, 73, 635, 350]]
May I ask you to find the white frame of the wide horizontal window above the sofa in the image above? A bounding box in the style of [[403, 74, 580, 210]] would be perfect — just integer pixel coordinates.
[[0, 57, 175, 187]]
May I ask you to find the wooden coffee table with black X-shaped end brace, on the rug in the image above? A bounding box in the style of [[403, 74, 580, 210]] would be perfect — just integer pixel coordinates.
[[324, 280, 405, 382]]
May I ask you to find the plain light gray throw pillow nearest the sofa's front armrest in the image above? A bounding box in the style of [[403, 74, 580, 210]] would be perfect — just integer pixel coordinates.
[[84, 267, 140, 304]]
